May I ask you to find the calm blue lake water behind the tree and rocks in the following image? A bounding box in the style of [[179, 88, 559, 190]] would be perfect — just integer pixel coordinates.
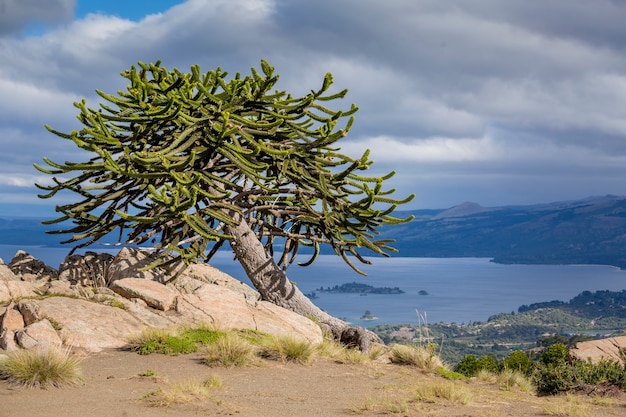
[[0, 245, 626, 326]]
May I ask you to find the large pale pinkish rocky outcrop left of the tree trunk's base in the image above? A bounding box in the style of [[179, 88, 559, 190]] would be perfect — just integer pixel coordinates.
[[0, 249, 322, 351]]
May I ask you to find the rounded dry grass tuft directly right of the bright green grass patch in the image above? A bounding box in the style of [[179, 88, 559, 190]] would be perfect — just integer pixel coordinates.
[[204, 333, 256, 367]]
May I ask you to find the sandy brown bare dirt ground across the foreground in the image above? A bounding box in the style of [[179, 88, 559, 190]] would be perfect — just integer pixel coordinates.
[[0, 351, 626, 417]]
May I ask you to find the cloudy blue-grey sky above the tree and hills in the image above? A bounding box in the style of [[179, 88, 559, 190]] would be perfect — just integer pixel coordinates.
[[0, 0, 626, 218]]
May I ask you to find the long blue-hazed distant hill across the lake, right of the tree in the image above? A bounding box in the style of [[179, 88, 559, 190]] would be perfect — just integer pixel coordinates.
[[381, 195, 626, 268]]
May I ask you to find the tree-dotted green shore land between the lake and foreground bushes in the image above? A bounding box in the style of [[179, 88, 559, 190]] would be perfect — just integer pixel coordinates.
[[371, 290, 626, 363]]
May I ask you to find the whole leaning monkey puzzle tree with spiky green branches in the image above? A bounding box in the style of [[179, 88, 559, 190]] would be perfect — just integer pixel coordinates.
[[35, 61, 413, 348]]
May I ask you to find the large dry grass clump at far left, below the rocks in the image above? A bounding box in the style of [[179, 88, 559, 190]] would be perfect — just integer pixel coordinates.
[[0, 347, 82, 388]]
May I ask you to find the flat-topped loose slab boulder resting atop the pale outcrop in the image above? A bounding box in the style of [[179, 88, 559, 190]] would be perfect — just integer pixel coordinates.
[[111, 278, 178, 311]]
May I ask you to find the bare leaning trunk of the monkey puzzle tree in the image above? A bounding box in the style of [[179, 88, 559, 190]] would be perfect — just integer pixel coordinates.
[[226, 219, 383, 351]]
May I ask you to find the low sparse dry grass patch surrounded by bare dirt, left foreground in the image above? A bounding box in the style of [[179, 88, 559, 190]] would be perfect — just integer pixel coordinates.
[[143, 375, 222, 407]]
